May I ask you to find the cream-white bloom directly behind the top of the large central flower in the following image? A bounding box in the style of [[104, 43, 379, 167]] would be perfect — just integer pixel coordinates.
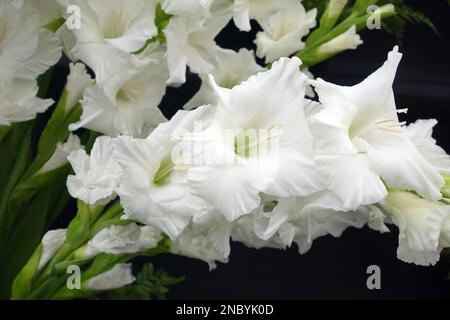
[[184, 49, 265, 109]]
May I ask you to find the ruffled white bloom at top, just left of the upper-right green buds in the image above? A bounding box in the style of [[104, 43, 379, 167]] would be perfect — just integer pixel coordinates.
[[255, 3, 317, 63]]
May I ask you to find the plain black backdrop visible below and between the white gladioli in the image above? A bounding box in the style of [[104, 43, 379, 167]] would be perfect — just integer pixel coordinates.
[[47, 0, 450, 299]]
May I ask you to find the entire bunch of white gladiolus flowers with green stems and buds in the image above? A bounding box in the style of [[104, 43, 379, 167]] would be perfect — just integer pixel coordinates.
[[0, 0, 450, 299]]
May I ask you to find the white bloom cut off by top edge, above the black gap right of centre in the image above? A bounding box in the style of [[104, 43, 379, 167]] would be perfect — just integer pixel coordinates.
[[233, 0, 299, 31]]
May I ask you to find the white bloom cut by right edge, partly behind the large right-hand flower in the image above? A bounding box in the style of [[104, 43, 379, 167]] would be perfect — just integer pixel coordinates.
[[404, 119, 450, 175]]
